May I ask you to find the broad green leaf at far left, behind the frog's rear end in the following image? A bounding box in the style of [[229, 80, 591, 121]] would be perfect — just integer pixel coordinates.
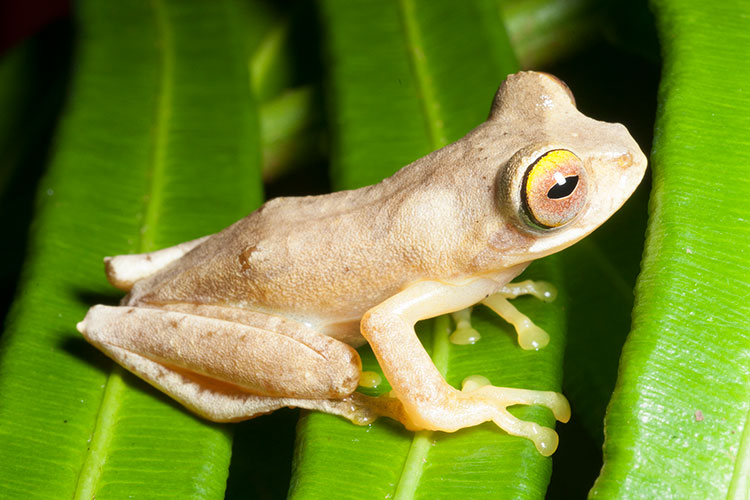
[[0, 0, 261, 500]]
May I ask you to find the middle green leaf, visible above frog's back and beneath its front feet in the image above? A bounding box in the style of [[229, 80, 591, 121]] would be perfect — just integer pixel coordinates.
[[290, 1, 576, 499]]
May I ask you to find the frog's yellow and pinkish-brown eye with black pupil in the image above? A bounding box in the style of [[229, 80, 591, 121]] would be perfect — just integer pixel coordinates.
[[521, 149, 587, 229]]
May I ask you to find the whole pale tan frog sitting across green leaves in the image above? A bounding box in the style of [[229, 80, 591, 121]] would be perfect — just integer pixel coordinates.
[[77, 71, 647, 456]]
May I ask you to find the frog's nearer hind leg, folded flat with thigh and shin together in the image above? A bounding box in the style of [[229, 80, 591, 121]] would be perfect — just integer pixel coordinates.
[[78, 304, 406, 424]]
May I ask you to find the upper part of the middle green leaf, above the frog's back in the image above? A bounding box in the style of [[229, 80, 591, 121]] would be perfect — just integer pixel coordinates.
[[320, 0, 517, 189]]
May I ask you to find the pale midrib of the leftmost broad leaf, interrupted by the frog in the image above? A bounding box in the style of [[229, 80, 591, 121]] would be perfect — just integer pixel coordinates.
[[73, 0, 174, 500]]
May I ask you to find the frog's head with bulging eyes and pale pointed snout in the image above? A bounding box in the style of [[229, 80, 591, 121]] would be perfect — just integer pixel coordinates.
[[488, 72, 647, 261]]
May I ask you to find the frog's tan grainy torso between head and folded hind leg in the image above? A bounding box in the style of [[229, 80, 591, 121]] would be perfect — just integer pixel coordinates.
[[128, 136, 525, 345]]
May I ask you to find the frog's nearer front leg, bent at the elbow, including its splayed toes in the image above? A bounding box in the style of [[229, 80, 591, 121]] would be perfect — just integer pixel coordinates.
[[362, 279, 570, 455]]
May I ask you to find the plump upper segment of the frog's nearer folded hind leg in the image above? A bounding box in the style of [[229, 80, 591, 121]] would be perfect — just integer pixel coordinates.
[[78, 306, 360, 406]]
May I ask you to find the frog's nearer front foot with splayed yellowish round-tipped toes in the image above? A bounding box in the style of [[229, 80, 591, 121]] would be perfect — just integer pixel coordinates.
[[414, 385, 570, 456]]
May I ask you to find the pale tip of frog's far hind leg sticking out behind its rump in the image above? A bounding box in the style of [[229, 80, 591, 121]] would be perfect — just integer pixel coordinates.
[[104, 236, 209, 292]]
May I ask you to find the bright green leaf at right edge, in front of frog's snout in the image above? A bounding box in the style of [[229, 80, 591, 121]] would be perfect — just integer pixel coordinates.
[[591, 0, 750, 499]]
